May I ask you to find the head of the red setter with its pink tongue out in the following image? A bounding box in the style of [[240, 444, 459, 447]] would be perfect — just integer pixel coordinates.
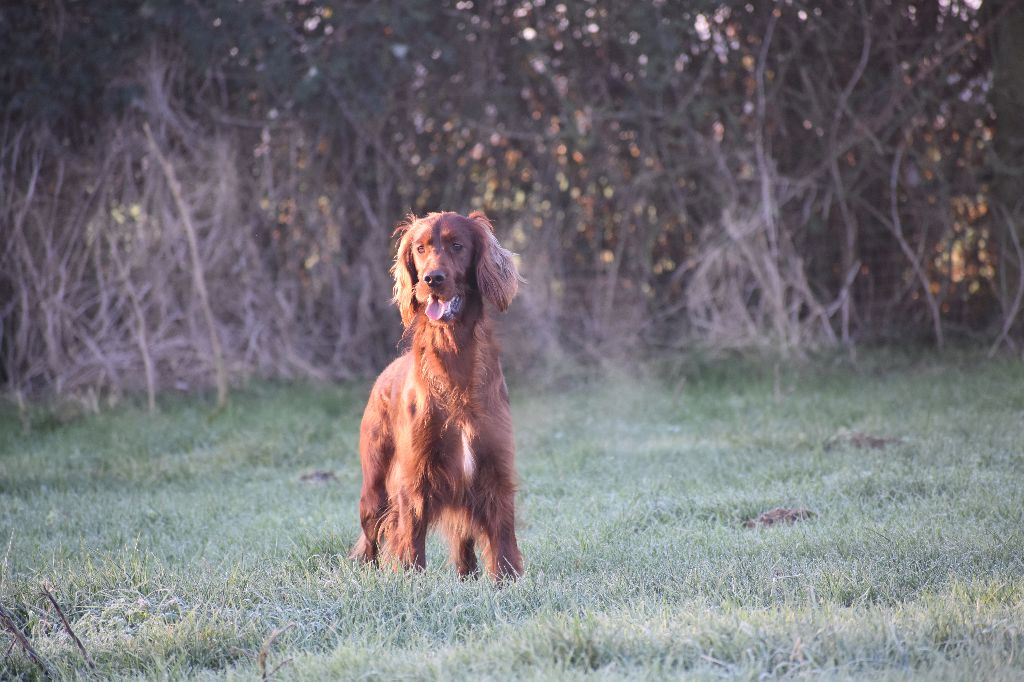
[[391, 211, 522, 327]]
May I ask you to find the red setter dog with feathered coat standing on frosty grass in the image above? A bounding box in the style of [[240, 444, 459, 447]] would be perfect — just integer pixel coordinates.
[[351, 212, 522, 580]]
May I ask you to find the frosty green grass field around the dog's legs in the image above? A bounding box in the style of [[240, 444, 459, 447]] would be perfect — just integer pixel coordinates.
[[0, 357, 1024, 680]]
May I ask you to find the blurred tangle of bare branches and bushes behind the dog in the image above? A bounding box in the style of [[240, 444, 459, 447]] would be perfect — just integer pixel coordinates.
[[0, 0, 1024, 402]]
